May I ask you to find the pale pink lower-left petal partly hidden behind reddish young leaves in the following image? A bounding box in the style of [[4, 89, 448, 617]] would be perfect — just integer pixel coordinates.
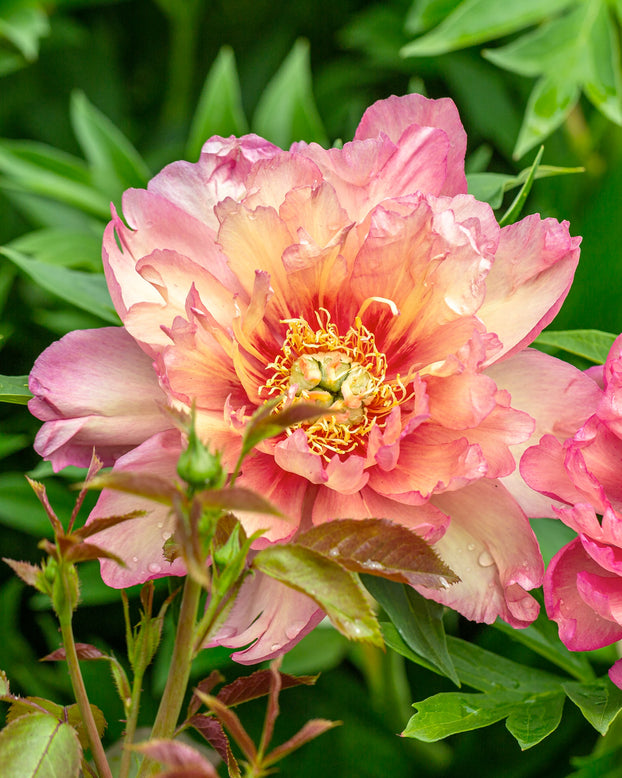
[[87, 430, 186, 589]]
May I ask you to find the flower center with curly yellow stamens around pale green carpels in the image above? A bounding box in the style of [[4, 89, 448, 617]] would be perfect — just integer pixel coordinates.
[[261, 308, 407, 459]]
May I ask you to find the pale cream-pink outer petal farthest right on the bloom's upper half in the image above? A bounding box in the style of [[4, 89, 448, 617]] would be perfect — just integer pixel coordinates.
[[479, 215, 581, 361]]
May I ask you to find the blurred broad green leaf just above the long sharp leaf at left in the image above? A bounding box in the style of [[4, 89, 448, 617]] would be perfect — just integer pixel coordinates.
[[7, 229, 102, 271]]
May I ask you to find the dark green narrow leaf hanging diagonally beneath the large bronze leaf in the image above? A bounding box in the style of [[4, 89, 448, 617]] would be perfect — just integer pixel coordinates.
[[363, 576, 460, 686]]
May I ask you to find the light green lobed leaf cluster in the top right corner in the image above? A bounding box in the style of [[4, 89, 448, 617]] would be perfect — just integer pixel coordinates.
[[401, 0, 622, 158]]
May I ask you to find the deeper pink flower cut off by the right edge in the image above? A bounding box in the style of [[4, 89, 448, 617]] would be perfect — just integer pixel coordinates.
[[521, 336, 622, 688]]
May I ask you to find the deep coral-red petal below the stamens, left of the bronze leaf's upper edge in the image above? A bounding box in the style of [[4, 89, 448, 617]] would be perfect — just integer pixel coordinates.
[[236, 452, 309, 548]]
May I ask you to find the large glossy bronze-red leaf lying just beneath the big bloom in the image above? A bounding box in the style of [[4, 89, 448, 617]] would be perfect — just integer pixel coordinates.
[[296, 519, 460, 589]]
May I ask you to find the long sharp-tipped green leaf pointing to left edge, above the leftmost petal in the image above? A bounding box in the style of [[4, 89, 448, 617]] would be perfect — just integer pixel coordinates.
[[0, 247, 120, 324]]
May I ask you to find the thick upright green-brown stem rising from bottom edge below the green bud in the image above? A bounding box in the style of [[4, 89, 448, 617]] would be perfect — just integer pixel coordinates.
[[140, 576, 202, 776]]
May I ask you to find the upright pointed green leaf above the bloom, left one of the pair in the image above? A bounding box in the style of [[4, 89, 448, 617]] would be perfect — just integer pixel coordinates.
[[186, 46, 248, 160]]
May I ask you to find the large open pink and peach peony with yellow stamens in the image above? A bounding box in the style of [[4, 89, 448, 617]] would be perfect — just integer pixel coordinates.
[[31, 95, 594, 662]]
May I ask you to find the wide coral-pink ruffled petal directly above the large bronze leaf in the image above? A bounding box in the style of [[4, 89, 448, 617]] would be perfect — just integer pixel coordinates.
[[312, 487, 449, 543]]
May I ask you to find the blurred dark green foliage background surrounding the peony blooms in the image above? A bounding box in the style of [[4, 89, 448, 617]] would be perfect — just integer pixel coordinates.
[[0, 0, 622, 778]]
